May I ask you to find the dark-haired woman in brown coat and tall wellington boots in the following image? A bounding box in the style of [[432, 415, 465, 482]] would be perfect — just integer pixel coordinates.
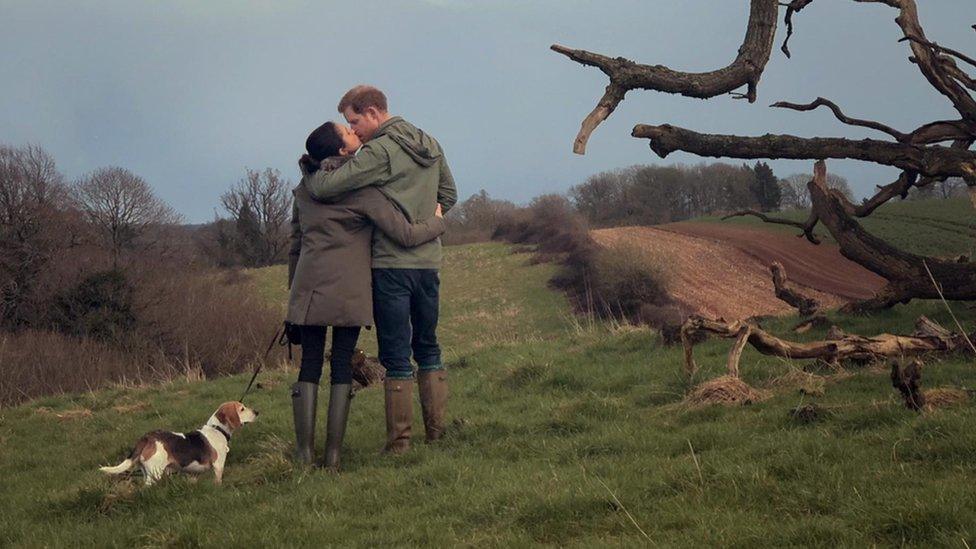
[[287, 122, 445, 470]]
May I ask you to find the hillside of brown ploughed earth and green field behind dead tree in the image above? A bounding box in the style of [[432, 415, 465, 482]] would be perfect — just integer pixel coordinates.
[[592, 196, 976, 318]]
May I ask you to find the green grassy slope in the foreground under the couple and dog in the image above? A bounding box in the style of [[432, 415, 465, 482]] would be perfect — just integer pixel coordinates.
[[0, 244, 976, 546]]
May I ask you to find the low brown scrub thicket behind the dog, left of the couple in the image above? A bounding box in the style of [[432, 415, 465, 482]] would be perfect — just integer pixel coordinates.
[[0, 265, 280, 406]]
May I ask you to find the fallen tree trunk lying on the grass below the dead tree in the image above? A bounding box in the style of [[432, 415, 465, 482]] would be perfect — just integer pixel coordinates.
[[681, 315, 976, 378]]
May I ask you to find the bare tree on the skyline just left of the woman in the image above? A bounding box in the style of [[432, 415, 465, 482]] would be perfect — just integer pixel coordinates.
[[220, 168, 292, 265]]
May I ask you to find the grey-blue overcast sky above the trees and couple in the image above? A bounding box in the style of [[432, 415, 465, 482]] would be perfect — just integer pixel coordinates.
[[0, 0, 976, 223]]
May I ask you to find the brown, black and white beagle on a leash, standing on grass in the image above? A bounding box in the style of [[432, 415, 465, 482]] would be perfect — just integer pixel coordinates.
[[99, 402, 258, 486]]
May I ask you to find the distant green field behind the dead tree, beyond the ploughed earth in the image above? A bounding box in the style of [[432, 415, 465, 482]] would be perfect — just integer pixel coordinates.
[[694, 198, 976, 257]]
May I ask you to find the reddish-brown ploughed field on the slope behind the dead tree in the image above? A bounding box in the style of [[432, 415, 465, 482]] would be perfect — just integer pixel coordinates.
[[592, 223, 884, 319]]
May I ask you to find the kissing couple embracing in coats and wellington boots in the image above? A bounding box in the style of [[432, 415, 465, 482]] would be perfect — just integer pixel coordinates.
[[287, 85, 457, 470]]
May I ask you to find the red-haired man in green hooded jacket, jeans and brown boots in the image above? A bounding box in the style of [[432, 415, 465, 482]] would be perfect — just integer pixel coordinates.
[[305, 86, 457, 453]]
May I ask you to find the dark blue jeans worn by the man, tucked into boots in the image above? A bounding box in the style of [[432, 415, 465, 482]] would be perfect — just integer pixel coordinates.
[[373, 269, 443, 379]]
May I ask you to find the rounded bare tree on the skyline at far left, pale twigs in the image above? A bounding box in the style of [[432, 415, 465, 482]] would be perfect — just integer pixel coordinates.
[[75, 167, 181, 263]]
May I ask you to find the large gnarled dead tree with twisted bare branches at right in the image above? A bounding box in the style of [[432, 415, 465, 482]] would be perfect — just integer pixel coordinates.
[[552, 0, 976, 311]]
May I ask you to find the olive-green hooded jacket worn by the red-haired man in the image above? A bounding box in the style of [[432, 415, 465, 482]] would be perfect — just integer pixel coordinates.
[[302, 116, 457, 269]]
